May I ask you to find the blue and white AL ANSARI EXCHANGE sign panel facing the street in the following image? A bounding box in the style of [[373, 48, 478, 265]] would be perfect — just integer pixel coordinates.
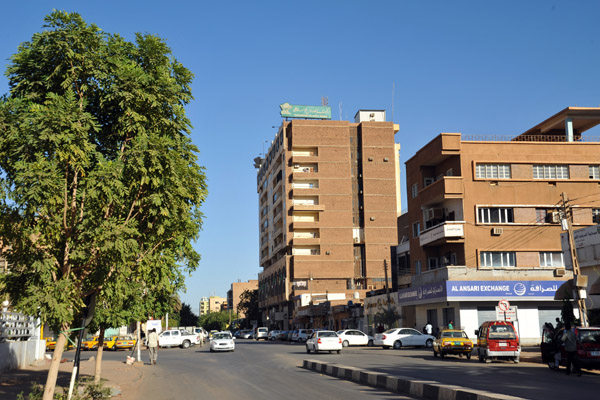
[[446, 281, 563, 298]]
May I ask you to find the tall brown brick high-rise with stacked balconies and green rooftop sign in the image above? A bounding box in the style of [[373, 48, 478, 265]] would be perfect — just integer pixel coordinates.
[[257, 110, 400, 329]]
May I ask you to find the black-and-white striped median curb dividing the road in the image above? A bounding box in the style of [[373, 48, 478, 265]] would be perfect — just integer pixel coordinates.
[[302, 360, 523, 400]]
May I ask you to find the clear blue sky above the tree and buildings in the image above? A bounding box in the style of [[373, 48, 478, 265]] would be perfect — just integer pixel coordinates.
[[0, 0, 600, 312]]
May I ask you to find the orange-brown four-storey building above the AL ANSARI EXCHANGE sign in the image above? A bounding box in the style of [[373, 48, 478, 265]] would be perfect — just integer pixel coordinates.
[[394, 107, 600, 343]]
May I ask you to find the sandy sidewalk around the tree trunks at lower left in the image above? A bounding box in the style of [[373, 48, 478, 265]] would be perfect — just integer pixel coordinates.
[[0, 353, 144, 400]]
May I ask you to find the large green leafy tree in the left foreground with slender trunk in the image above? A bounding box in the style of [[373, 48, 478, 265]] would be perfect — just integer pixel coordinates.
[[0, 11, 207, 400]]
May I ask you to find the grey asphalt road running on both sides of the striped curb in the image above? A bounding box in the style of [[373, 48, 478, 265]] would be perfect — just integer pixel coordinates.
[[98, 340, 600, 400]]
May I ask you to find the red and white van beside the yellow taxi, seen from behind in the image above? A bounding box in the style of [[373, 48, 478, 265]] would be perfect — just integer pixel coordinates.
[[475, 321, 521, 363]]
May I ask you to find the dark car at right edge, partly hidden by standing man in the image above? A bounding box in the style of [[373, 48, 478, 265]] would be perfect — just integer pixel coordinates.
[[540, 326, 600, 369]]
